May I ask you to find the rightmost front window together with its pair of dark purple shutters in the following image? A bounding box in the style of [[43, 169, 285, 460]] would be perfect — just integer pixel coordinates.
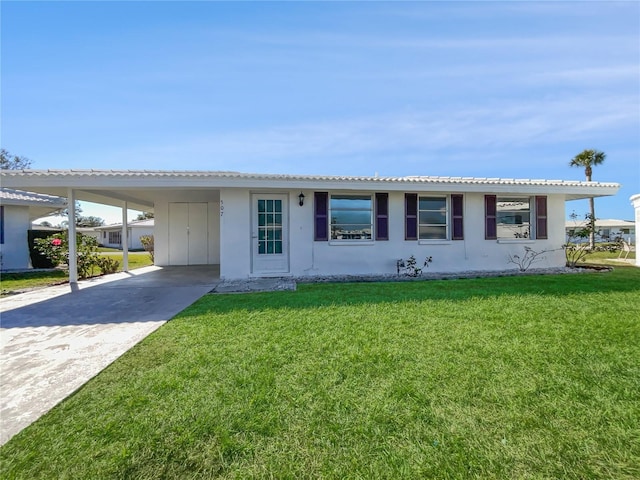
[[484, 195, 547, 240]]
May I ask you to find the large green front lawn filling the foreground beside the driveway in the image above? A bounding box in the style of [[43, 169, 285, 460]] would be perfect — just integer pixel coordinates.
[[0, 267, 640, 479]]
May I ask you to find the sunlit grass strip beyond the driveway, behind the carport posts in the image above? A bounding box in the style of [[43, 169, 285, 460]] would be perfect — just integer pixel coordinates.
[[0, 252, 153, 295]]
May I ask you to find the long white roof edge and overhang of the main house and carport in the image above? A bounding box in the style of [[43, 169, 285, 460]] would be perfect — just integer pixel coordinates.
[[0, 170, 620, 206]]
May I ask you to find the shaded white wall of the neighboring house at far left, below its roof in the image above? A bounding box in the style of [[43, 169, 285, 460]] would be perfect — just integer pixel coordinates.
[[0, 205, 31, 270]]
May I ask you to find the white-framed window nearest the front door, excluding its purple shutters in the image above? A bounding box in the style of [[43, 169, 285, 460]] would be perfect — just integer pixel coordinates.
[[329, 194, 373, 241]]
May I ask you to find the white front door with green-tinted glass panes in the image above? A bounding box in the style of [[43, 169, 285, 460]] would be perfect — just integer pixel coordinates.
[[251, 194, 289, 275]]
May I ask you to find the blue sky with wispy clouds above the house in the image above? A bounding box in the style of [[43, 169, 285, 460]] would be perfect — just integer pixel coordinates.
[[0, 0, 640, 223]]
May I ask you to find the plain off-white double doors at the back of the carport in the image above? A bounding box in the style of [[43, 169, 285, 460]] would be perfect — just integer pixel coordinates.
[[169, 203, 209, 265]]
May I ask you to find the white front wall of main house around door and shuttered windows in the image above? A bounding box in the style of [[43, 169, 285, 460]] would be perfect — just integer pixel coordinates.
[[220, 189, 565, 279]]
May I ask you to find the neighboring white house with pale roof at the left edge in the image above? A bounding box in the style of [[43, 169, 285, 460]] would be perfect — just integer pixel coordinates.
[[0, 188, 67, 270]]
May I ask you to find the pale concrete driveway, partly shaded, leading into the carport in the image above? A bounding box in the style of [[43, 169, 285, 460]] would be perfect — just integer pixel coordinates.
[[0, 265, 220, 445]]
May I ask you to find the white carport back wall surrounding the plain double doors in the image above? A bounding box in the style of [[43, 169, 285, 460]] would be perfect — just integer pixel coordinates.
[[153, 190, 220, 266]]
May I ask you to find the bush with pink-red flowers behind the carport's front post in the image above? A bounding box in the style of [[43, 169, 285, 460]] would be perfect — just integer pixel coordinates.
[[34, 231, 100, 278]]
